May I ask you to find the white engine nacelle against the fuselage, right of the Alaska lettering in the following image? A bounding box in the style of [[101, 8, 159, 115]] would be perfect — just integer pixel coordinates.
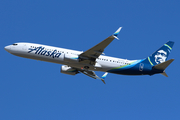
[[64, 54, 79, 62]]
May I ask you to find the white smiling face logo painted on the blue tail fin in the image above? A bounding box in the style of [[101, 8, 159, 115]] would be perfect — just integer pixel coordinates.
[[154, 50, 167, 64]]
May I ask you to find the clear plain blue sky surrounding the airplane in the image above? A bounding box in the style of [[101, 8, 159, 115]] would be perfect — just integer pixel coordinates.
[[0, 0, 180, 120]]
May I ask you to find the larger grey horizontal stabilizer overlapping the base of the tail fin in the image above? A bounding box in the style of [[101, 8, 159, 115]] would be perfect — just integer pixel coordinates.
[[153, 59, 174, 70]]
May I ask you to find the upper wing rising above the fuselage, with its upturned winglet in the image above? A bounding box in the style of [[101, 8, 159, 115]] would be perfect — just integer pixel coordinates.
[[79, 27, 122, 65]]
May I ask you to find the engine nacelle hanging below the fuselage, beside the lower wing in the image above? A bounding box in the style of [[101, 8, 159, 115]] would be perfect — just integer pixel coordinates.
[[61, 65, 79, 75]]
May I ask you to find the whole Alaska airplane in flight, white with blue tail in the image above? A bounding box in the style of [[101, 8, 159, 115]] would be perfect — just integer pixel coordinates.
[[4, 27, 174, 84]]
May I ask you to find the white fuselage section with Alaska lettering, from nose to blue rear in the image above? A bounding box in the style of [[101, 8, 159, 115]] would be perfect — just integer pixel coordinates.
[[5, 43, 136, 72]]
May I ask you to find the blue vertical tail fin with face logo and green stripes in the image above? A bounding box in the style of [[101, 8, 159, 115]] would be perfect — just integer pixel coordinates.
[[147, 41, 174, 66]]
